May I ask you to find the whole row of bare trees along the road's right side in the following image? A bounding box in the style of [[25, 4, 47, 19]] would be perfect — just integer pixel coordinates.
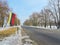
[[23, 0, 60, 28]]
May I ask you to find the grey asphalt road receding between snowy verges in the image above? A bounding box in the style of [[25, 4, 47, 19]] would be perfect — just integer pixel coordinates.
[[22, 26, 60, 45]]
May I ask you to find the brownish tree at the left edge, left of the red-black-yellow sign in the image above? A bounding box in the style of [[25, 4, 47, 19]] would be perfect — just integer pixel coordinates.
[[0, 0, 9, 27]]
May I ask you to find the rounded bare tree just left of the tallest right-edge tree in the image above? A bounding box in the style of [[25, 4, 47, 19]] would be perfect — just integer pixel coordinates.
[[41, 8, 50, 27]]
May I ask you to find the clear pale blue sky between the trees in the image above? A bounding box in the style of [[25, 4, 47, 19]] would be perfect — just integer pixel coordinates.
[[7, 0, 48, 24]]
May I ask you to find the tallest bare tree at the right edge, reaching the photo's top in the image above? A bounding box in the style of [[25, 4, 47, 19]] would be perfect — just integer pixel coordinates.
[[49, 0, 60, 27]]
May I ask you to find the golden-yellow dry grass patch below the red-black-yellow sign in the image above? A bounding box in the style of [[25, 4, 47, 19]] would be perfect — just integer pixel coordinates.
[[0, 27, 17, 38]]
